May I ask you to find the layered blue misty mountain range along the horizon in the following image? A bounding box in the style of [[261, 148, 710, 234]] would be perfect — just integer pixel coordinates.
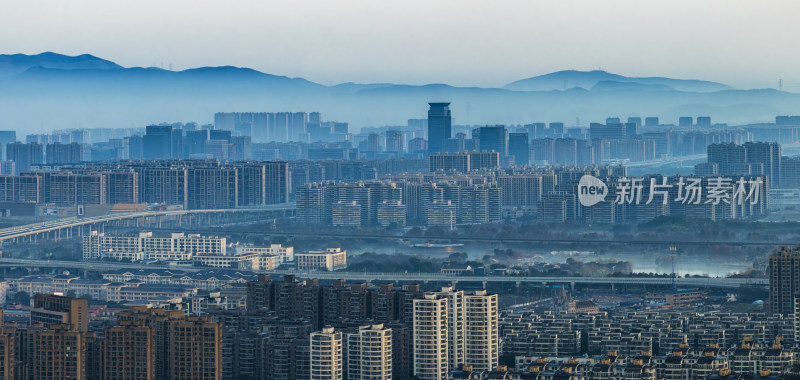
[[0, 53, 800, 133]]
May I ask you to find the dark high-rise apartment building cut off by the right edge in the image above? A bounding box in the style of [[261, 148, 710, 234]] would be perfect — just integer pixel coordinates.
[[769, 247, 800, 315]]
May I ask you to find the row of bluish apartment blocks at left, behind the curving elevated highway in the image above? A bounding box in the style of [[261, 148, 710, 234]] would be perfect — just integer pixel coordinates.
[[0, 160, 289, 215]]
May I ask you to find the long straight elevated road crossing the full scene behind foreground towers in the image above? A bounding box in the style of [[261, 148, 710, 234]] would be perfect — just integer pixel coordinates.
[[0, 258, 769, 288]]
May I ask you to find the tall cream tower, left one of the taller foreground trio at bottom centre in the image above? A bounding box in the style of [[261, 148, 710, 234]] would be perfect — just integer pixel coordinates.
[[413, 294, 449, 380]]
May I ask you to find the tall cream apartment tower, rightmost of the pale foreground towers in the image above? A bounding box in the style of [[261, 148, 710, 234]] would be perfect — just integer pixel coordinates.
[[464, 290, 500, 371]]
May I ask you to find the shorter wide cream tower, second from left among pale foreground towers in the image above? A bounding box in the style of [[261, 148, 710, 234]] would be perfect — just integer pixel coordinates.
[[346, 324, 392, 380]]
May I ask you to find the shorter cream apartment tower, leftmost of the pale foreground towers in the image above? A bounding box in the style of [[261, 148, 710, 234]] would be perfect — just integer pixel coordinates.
[[310, 327, 344, 380]]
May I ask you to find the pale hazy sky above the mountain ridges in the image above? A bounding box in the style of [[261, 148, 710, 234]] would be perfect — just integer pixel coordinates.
[[0, 0, 800, 92]]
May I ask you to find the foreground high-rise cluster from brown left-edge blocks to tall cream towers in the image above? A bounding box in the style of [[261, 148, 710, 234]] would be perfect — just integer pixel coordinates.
[[0, 276, 500, 380]]
